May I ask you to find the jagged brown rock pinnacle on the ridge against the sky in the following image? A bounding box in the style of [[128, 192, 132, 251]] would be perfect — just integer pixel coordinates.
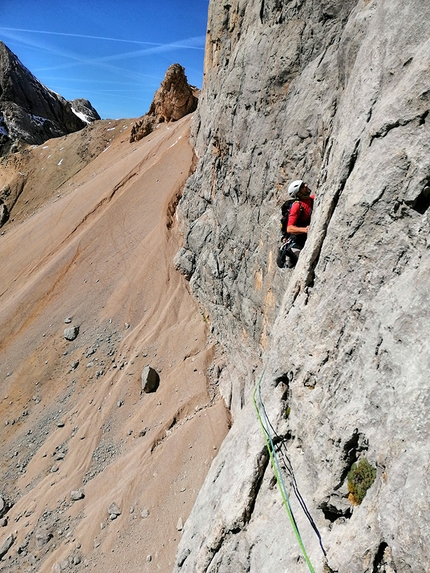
[[130, 64, 198, 142]]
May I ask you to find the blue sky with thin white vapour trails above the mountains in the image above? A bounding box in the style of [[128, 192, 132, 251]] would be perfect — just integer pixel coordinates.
[[0, 0, 209, 119]]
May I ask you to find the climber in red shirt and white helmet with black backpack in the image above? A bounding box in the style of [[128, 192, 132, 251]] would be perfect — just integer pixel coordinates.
[[277, 179, 315, 268]]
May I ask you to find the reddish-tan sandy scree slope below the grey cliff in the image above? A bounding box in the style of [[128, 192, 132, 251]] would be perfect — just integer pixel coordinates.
[[0, 117, 228, 573]]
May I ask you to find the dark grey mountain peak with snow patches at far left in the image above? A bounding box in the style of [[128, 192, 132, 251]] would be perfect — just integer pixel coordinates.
[[0, 42, 98, 155]]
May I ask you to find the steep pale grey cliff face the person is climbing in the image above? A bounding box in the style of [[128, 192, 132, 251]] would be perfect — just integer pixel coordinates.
[[175, 0, 430, 573]]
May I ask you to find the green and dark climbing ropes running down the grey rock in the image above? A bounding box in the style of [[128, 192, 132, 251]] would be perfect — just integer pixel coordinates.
[[252, 370, 325, 573]]
